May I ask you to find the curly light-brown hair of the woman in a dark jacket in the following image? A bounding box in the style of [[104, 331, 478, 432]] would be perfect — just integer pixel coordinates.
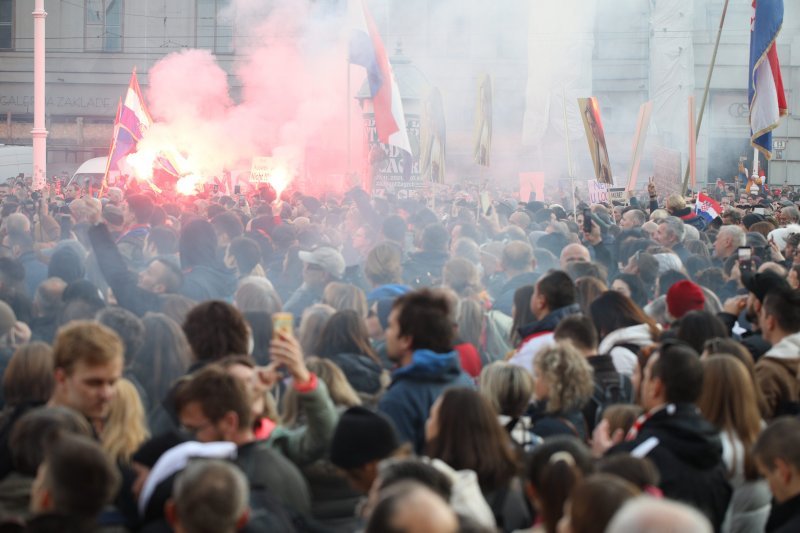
[[534, 342, 594, 413]]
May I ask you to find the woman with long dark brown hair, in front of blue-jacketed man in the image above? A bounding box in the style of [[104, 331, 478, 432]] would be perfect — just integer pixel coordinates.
[[425, 388, 531, 531]]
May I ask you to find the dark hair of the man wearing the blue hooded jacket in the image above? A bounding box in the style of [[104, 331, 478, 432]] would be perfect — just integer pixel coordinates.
[[392, 289, 454, 353]]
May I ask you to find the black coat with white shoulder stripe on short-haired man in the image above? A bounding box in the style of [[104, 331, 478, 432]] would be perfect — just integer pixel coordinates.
[[608, 403, 732, 531]]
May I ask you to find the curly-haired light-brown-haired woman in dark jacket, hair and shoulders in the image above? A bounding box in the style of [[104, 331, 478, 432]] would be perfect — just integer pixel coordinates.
[[533, 342, 594, 442]]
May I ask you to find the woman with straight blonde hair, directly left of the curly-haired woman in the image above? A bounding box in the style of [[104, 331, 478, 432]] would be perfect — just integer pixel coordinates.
[[478, 361, 539, 452]]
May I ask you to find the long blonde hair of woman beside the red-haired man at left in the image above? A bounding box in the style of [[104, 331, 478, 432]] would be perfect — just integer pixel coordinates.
[[100, 378, 150, 465]]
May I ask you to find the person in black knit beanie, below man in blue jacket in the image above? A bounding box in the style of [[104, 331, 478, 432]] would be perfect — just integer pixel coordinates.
[[330, 406, 404, 494]]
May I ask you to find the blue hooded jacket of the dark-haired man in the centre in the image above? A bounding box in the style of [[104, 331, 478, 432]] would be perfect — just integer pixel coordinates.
[[378, 350, 473, 454]]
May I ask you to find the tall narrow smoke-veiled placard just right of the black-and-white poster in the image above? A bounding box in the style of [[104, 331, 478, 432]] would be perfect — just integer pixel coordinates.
[[419, 87, 447, 183]]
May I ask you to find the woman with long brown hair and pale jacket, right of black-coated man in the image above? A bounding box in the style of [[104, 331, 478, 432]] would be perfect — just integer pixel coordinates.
[[697, 355, 771, 532]]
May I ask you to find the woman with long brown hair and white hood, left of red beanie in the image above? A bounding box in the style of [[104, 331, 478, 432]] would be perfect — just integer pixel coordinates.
[[589, 291, 661, 377]]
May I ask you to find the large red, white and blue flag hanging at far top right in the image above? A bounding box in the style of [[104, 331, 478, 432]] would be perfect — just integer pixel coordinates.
[[748, 0, 787, 159]]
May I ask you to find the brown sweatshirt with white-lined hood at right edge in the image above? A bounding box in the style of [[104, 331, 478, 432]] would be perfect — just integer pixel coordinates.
[[756, 332, 800, 419]]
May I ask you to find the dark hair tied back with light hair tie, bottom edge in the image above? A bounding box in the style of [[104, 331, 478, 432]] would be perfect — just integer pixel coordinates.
[[525, 435, 593, 532]]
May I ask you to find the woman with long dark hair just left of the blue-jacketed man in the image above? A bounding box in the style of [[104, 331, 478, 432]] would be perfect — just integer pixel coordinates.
[[313, 309, 388, 397]]
